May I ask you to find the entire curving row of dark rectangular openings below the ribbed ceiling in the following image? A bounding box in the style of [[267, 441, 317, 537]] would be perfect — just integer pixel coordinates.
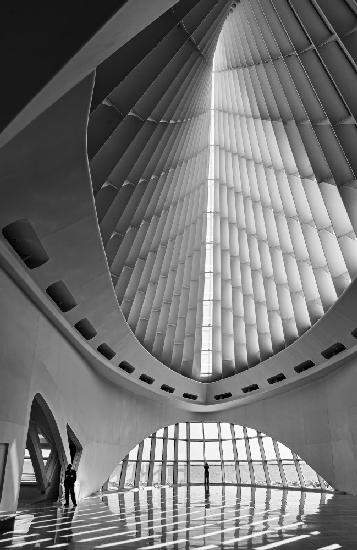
[[2, 219, 350, 401]]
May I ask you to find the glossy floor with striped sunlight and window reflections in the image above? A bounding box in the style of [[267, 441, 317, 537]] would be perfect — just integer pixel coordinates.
[[0, 486, 357, 550]]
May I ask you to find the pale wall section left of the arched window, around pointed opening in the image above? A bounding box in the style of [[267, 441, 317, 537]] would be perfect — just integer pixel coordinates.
[[0, 271, 192, 511]]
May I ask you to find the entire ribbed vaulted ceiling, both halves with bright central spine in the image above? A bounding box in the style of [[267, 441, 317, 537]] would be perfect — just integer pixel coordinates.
[[88, 0, 357, 380]]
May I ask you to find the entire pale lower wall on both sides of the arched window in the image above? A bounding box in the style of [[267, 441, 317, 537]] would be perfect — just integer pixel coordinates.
[[0, 260, 357, 510]]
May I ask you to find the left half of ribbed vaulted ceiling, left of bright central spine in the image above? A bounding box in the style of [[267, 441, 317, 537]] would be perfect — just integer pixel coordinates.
[[88, 0, 230, 380]]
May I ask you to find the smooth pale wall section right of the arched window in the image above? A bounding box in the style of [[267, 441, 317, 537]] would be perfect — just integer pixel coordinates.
[[202, 356, 357, 494]]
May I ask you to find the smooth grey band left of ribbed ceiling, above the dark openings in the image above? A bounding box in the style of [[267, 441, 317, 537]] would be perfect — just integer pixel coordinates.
[[0, 74, 205, 408]]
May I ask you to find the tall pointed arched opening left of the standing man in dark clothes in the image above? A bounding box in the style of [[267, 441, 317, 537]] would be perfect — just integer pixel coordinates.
[[19, 394, 67, 502]]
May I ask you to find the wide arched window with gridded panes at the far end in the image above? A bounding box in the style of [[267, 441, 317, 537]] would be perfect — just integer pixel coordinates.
[[109, 422, 333, 491]]
